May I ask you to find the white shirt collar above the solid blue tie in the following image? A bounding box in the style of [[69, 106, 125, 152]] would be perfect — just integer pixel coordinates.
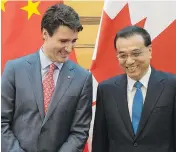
[[127, 66, 151, 91]]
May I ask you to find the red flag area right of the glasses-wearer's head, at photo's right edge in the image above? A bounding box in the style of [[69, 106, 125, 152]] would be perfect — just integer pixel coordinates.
[[151, 20, 176, 74]]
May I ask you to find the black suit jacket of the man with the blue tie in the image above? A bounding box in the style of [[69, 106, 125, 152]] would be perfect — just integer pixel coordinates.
[[92, 69, 176, 152]]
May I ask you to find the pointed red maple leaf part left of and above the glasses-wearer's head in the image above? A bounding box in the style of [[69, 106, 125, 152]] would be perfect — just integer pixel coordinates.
[[91, 4, 146, 82]]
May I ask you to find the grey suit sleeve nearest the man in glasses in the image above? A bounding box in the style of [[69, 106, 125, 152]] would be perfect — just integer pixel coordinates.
[[58, 74, 92, 152]]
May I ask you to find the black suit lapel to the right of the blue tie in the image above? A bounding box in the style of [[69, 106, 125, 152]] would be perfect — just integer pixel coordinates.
[[135, 69, 164, 138]]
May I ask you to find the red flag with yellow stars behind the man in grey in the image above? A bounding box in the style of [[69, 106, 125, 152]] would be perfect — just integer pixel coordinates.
[[1, 0, 77, 71]]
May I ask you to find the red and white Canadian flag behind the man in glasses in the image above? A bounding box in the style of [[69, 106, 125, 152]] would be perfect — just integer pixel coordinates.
[[89, 0, 176, 152]]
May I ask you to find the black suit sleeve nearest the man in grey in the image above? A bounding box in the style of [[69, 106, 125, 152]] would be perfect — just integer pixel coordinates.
[[92, 86, 109, 152]]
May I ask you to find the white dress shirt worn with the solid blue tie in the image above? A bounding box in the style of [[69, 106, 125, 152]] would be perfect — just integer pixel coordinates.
[[127, 66, 151, 120]]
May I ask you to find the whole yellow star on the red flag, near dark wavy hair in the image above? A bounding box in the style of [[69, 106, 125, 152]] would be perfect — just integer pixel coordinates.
[[21, 0, 40, 20]]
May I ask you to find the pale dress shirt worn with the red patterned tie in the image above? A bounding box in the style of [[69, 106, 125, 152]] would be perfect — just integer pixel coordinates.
[[39, 48, 63, 86]]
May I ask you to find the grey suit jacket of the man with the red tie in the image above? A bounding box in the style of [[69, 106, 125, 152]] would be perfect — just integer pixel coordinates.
[[1, 52, 92, 152]]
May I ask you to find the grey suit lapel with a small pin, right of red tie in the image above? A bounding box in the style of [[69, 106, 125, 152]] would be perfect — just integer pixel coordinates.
[[43, 60, 74, 125]]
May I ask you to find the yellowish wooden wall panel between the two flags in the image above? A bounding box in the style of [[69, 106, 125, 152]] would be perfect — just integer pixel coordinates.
[[64, 1, 104, 69]]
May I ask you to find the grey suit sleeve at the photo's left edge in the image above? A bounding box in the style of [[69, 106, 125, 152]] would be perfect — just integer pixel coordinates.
[[1, 61, 24, 152]]
